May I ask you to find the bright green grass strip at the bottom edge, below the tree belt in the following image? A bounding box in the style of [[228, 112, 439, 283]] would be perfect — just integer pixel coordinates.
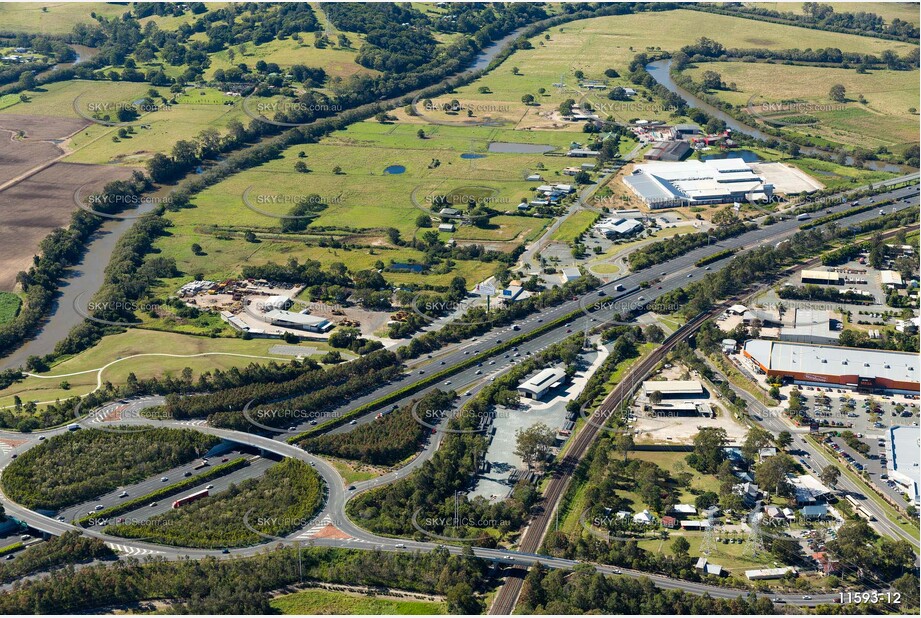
[[270, 590, 448, 616]]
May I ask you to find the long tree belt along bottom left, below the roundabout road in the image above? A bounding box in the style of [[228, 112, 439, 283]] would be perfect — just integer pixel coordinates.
[[0, 541, 495, 615]]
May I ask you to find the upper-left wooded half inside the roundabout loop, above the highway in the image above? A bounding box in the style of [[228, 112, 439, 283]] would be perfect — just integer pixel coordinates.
[[3, 428, 220, 510]]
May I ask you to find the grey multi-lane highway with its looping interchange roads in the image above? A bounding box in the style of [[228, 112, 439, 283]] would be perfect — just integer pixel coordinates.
[[0, 177, 918, 606]]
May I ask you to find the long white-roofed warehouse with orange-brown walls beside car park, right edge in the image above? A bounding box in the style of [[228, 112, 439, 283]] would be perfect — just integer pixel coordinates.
[[742, 339, 921, 394]]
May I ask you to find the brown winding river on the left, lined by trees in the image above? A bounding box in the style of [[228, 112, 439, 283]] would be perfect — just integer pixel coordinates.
[[0, 28, 525, 370]]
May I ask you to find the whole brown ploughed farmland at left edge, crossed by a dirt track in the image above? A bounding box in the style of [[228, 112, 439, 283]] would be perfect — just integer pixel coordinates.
[[0, 114, 131, 291]]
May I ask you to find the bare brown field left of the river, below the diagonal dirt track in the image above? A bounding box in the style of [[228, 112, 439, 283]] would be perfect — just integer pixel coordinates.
[[0, 161, 132, 291]]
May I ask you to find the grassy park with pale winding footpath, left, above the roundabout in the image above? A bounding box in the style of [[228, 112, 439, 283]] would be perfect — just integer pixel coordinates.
[[0, 329, 329, 407]]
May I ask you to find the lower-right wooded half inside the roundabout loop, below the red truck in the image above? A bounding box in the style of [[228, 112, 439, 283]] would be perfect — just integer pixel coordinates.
[[104, 458, 323, 548]]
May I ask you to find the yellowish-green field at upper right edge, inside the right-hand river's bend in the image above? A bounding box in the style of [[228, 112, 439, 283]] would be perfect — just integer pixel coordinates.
[[686, 62, 921, 149]]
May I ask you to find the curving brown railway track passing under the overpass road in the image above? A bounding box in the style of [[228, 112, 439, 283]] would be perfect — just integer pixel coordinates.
[[489, 305, 723, 615]]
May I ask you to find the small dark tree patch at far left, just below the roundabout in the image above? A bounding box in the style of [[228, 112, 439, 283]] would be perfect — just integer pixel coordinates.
[[0, 531, 115, 584]]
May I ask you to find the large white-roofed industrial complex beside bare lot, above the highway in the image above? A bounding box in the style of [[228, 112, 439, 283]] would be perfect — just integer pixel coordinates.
[[623, 158, 774, 208]]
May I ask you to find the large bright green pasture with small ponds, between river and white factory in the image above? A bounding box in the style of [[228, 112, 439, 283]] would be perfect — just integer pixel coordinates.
[[148, 121, 569, 290]]
